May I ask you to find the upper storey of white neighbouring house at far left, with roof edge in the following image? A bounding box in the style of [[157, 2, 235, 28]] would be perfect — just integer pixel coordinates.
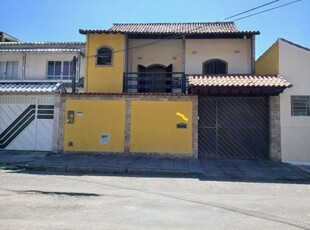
[[0, 42, 85, 89]]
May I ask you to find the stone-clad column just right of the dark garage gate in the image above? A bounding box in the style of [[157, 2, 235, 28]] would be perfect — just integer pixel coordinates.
[[269, 96, 282, 161]]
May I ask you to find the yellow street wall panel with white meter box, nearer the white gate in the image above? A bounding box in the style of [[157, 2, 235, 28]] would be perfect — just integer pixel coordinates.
[[64, 100, 125, 152]]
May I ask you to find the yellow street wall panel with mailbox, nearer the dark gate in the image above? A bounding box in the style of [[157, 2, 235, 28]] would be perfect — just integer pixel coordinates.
[[130, 101, 192, 154]]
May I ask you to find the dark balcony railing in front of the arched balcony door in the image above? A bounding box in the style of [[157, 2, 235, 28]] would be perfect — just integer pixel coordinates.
[[123, 72, 188, 93]]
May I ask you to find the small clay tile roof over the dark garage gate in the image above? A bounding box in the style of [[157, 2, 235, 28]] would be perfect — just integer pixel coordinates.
[[189, 74, 292, 88]]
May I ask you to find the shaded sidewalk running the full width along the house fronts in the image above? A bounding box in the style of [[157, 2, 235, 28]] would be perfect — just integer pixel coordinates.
[[0, 150, 310, 183]]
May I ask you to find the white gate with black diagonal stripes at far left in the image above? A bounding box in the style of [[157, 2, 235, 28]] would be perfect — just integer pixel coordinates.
[[0, 95, 55, 151]]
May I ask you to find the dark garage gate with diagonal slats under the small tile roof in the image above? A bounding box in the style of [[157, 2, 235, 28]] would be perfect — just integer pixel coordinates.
[[198, 97, 269, 159]]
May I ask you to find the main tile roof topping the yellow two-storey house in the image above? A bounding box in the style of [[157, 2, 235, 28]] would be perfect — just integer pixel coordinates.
[[80, 22, 259, 34]]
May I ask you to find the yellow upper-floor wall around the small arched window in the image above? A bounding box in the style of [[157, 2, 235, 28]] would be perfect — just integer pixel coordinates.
[[85, 34, 125, 93]]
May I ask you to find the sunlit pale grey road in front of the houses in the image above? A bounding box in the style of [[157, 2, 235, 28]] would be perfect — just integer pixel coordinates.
[[0, 170, 310, 230]]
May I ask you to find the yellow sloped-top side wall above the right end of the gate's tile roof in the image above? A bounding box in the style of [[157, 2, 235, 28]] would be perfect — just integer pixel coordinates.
[[255, 42, 279, 74]]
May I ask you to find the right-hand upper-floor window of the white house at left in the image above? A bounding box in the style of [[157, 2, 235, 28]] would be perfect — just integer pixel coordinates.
[[47, 61, 73, 80]]
